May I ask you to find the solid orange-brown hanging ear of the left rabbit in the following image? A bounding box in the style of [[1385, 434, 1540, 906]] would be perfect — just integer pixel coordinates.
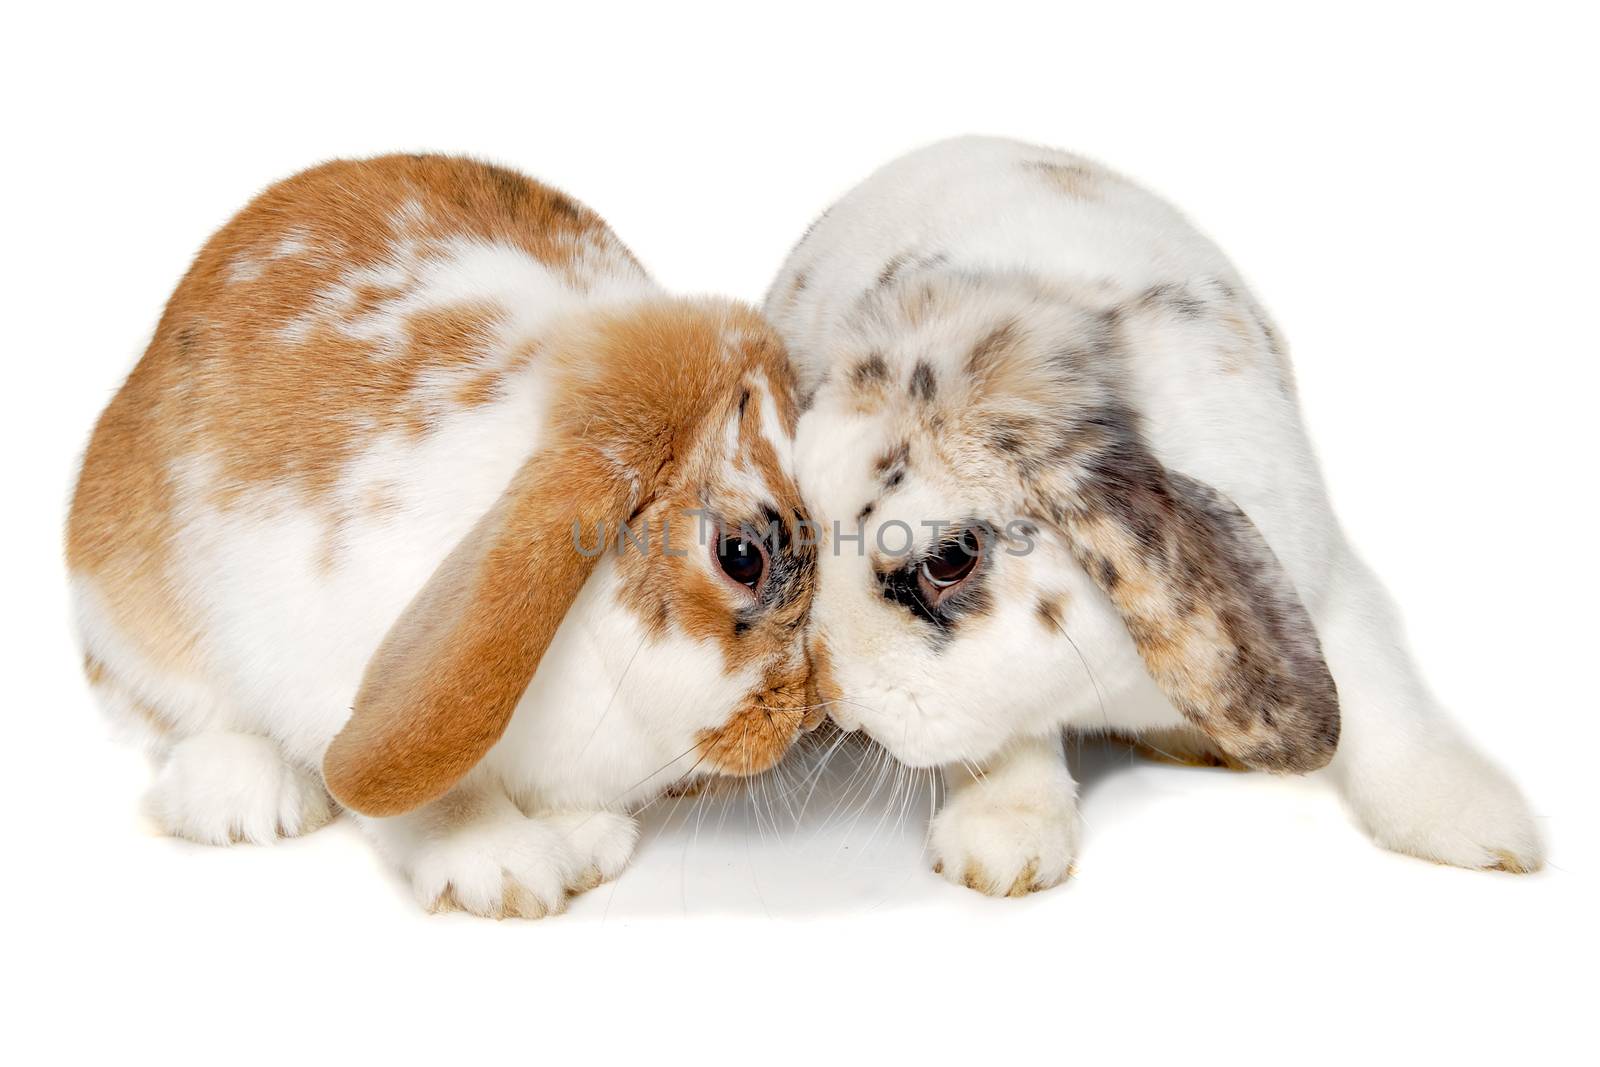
[[323, 446, 648, 816]]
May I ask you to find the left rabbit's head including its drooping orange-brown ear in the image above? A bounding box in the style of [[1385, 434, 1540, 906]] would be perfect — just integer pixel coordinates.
[[323, 301, 816, 814]]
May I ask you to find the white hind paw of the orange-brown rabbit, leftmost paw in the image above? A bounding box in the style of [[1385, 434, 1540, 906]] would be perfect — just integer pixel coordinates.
[[144, 733, 334, 845]]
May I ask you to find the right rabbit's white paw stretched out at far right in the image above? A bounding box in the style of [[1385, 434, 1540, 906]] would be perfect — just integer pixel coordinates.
[[1346, 742, 1544, 873]]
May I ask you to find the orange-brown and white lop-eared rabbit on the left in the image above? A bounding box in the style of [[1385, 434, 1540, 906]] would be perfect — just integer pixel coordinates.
[[66, 155, 819, 918]]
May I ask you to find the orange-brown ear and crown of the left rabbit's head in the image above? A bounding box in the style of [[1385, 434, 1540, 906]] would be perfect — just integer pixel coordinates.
[[322, 299, 782, 816]]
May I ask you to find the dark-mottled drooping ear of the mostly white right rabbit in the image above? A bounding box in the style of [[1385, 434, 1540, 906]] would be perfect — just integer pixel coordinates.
[[1058, 435, 1339, 773]]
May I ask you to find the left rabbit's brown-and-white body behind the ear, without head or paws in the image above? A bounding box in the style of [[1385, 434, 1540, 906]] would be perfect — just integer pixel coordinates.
[[67, 155, 656, 761]]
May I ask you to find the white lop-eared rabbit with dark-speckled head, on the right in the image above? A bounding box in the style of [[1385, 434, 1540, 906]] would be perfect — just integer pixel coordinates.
[[765, 138, 1542, 894]]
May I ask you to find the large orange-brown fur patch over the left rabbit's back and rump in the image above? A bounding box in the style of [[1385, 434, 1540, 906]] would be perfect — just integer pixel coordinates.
[[66, 155, 643, 684]]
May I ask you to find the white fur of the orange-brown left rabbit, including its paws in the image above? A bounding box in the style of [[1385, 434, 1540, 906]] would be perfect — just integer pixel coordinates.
[[72, 223, 787, 917]]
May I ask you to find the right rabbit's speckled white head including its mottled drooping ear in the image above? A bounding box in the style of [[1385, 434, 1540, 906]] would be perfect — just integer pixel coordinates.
[[797, 270, 1338, 769]]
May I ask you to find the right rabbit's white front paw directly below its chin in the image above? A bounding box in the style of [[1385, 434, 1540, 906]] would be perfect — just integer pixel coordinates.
[[930, 769, 1078, 896]]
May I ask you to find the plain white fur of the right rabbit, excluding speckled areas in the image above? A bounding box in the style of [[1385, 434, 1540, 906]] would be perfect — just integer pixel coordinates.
[[766, 138, 1541, 893]]
